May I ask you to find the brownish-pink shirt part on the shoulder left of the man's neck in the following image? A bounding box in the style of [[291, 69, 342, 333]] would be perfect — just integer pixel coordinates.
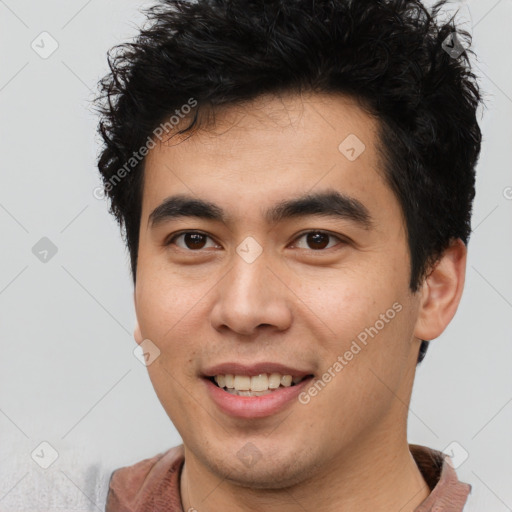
[[105, 445, 184, 512]]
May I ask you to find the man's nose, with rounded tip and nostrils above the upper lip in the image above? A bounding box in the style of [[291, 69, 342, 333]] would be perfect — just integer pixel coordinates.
[[211, 252, 293, 337]]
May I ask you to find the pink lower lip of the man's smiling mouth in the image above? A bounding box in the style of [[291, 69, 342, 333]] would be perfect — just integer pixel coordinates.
[[203, 377, 313, 418]]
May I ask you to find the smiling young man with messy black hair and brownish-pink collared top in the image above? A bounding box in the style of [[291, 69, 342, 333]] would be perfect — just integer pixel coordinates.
[[94, 0, 481, 512]]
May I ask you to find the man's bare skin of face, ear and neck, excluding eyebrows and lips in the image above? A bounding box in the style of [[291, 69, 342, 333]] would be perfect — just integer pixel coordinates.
[[134, 94, 466, 512]]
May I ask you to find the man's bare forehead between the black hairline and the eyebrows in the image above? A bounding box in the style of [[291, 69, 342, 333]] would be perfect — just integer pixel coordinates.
[[142, 94, 400, 229]]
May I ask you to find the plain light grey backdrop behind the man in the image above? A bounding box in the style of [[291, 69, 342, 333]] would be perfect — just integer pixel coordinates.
[[0, 0, 512, 512]]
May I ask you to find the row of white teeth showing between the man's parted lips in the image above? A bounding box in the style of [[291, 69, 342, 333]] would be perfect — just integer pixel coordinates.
[[209, 373, 313, 396]]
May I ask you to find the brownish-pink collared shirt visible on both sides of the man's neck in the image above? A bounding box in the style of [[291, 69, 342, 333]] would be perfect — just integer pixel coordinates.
[[105, 444, 471, 512]]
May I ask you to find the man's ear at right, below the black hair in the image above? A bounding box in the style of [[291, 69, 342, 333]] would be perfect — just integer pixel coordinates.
[[414, 238, 467, 341]]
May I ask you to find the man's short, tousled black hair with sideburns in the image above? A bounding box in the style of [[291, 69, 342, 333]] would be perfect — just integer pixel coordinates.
[[96, 0, 482, 362]]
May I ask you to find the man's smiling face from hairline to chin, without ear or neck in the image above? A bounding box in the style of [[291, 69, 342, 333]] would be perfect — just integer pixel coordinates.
[[135, 95, 419, 487]]
